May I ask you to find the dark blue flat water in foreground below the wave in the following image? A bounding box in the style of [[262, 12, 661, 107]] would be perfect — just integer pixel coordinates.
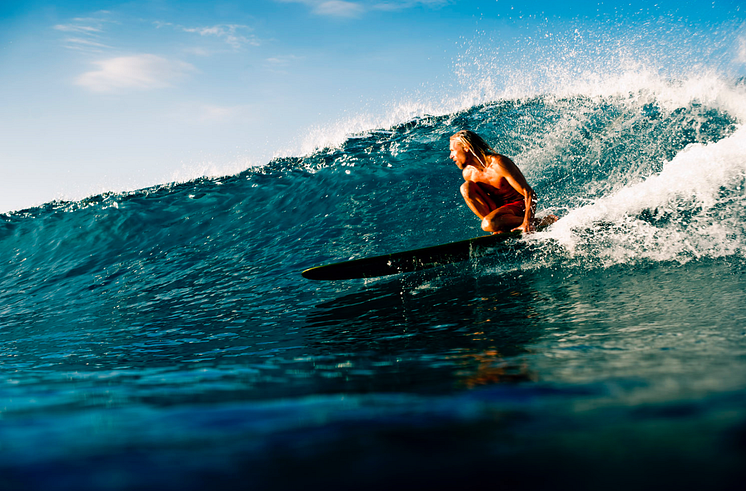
[[0, 261, 746, 489]]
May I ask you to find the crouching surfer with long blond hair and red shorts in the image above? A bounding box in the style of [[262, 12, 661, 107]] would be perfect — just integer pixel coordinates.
[[450, 130, 557, 234]]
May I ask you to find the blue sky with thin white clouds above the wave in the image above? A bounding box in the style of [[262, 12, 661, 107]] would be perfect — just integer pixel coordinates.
[[0, 0, 746, 213]]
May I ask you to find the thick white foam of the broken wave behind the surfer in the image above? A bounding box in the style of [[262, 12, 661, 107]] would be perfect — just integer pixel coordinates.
[[547, 121, 746, 265]]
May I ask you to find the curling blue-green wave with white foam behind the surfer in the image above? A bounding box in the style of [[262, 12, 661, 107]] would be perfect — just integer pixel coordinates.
[[0, 77, 746, 316]]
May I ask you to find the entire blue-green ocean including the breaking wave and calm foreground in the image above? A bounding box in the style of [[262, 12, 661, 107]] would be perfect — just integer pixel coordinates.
[[0, 75, 746, 491]]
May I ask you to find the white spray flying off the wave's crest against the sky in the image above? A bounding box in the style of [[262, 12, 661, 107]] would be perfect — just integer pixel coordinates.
[[284, 18, 746, 163]]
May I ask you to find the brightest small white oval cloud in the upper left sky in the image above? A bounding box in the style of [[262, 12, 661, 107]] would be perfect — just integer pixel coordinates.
[[75, 54, 196, 92]]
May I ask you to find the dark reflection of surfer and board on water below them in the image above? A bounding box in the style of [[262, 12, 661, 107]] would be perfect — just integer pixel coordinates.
[[304, 275, 543, 392]]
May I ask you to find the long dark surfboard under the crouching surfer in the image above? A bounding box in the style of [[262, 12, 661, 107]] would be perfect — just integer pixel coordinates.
[[301, 231, 521, 280]]
